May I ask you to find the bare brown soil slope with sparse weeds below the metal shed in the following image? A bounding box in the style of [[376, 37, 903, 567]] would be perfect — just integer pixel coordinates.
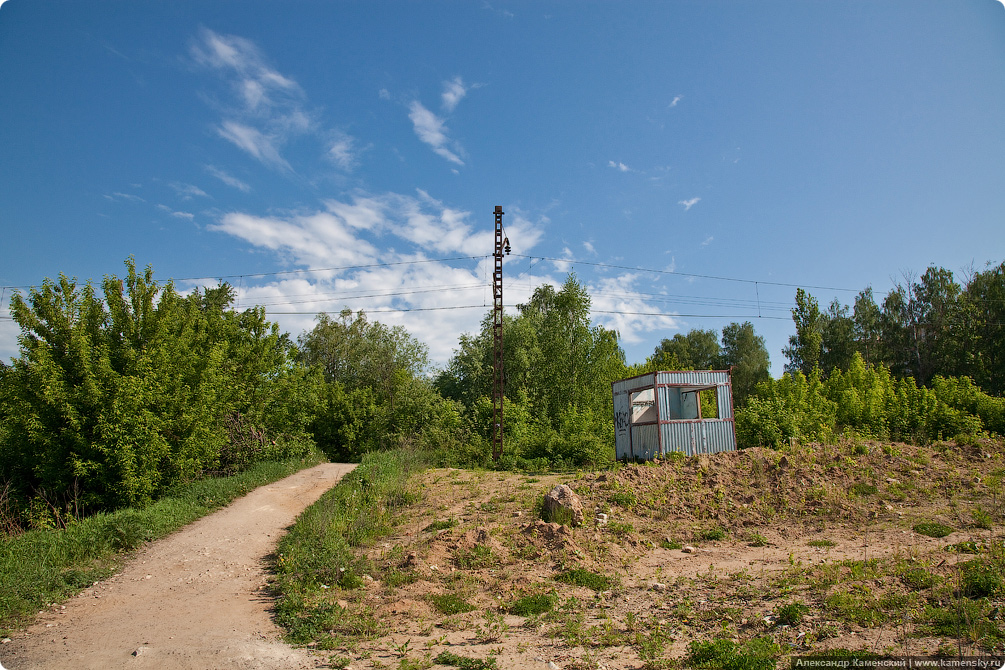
[[330, 442, 1005, 670]]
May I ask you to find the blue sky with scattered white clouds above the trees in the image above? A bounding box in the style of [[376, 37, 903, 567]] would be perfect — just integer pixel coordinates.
[[0, 0, 1005, 375]]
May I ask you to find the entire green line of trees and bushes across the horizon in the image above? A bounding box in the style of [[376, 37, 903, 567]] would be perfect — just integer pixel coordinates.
[[0, 259, 1005, 527]]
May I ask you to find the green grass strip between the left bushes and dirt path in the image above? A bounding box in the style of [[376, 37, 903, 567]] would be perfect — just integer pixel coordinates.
[[0, 455, 321, 634]]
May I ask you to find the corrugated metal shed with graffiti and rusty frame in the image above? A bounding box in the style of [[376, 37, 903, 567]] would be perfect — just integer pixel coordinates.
[[611, 370, 737, 460]]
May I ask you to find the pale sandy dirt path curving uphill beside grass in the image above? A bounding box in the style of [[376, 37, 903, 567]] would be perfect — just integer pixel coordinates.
[[0, 463, 355, 670]]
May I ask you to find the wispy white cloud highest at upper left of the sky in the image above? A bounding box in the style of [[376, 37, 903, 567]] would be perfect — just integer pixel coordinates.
[[189, 28, 316, 170]]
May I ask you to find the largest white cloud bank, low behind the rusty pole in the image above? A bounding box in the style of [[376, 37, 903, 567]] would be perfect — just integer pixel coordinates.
[[210, 191, 546, 365]]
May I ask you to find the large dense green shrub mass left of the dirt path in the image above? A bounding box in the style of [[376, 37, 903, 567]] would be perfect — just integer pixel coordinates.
[[0, 260, 311, 525]]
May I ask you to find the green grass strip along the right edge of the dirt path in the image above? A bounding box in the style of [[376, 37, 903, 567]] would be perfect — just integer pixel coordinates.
[[273, 451, 424, 649]]
